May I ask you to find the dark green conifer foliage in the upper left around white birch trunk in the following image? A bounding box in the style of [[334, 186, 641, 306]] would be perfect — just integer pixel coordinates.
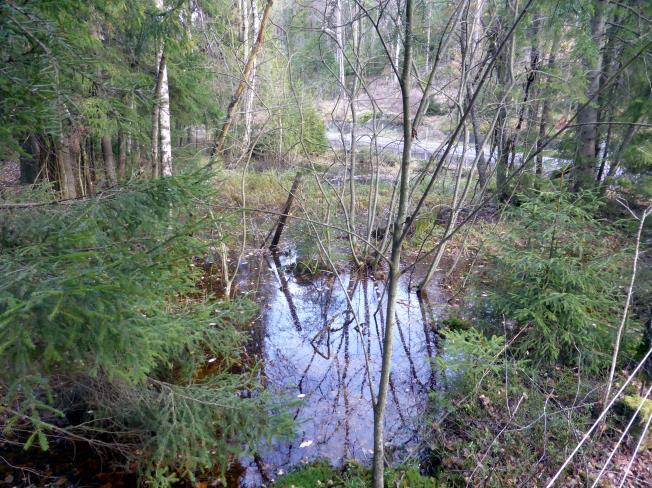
[[0, 0, 220, 164]]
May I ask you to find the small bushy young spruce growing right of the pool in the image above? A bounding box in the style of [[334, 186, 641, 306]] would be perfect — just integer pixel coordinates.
[[478, 192, 622, 370]]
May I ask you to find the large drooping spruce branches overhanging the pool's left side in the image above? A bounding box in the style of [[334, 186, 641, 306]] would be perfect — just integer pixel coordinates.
[[0, 174, 287, 485]]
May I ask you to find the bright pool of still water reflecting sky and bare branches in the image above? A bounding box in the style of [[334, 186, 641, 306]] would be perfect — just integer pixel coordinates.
[[241, 252, 444, 486]]
